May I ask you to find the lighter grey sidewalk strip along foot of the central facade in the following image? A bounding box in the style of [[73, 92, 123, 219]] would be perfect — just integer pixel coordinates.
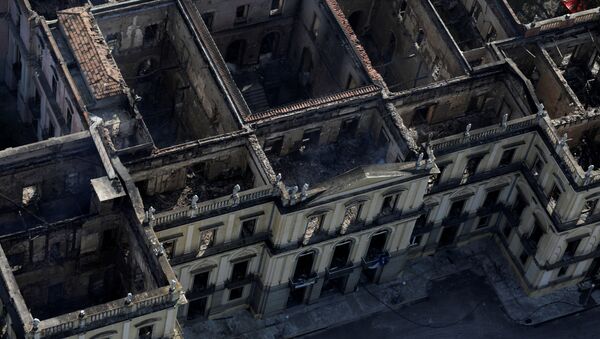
[[182, 279, 429, 339]]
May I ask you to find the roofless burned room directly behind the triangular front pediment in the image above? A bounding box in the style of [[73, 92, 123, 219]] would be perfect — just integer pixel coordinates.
[[263, 113, 397, 187]]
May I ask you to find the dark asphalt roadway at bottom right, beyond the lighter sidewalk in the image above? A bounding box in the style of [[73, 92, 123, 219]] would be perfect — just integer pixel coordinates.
[[305, 271, 600, 339]]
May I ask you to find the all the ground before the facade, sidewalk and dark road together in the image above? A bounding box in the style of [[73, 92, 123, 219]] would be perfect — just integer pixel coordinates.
[[182, 239, 600, 339]]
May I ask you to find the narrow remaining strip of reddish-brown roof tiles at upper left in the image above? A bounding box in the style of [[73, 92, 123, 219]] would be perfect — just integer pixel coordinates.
[[57, 7, 125, 100]]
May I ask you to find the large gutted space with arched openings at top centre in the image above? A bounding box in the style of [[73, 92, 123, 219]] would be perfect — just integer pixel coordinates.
[[196, 0, 368, 112]]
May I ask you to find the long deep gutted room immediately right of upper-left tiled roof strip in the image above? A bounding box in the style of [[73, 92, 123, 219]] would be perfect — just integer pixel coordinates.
[[97, 4, 237, 148]]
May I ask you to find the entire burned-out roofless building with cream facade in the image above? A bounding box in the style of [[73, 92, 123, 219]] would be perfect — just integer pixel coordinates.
[[0, 0, 600, 338]]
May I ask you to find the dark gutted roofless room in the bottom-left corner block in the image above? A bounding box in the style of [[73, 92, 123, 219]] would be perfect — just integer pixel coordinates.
[[0, 216, 151, 320]]
